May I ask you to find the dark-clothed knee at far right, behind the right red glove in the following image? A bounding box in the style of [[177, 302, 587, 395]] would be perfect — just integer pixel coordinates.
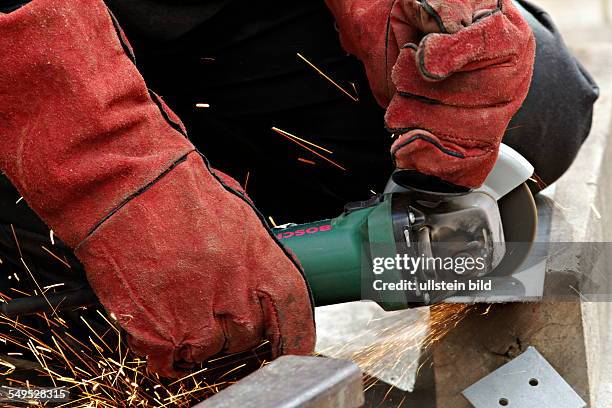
[[504, 1, 599, 187]]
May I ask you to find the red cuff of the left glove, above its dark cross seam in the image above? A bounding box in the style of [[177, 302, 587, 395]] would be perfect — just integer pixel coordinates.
[[0, 0, 194, 247]]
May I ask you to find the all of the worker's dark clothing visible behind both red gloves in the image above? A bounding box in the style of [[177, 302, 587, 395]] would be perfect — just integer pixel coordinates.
[[0, 0, 597, 242]]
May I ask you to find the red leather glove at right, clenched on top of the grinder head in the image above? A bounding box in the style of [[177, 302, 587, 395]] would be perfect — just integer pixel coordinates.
[[327, 0, 535, 187]]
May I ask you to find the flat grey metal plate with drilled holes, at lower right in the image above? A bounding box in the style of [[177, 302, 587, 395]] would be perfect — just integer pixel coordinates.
[[462, 347, 587, 408]]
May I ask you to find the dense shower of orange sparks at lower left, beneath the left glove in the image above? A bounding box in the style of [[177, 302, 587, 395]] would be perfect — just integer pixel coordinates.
[[0, 229, 265, 408]]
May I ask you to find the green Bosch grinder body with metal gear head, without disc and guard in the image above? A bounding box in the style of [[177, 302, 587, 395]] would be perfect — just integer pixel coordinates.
[[275, 187, 516, 310]]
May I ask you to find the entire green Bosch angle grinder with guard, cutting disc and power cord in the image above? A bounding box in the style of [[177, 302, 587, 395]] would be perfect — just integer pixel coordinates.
[[0, 145, 537, 317]]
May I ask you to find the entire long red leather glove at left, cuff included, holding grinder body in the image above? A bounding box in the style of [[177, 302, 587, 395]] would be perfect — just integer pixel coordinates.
[[0, 0, 315, 376]]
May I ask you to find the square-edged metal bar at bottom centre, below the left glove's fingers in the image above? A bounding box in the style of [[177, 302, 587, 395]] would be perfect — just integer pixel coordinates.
[[194, 356, 364, 408]]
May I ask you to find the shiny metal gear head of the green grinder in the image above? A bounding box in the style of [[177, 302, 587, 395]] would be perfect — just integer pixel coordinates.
[[391, 188, 506, 304]]
